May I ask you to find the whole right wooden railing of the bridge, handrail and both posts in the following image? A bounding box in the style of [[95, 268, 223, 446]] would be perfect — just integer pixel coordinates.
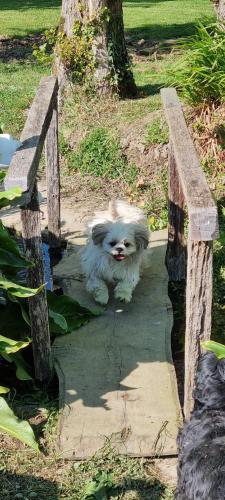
[[161, 88, 219, 418]]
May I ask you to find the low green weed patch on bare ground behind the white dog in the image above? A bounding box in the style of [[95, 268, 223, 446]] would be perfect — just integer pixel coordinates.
[[68, 128, 126, 179]]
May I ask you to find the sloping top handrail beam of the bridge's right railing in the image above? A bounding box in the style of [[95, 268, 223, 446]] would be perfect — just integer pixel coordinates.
[[161, 88, 219, 241]]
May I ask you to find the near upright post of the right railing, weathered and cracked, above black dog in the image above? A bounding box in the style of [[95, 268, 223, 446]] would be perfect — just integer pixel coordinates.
[[184, 239, 213, 419]]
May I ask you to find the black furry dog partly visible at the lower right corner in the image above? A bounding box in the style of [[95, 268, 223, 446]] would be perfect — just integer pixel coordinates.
[[175, 353, 225, 500]]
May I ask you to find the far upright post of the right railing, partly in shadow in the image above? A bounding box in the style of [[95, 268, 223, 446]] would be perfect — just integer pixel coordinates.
[[166, 144, 186, 281]]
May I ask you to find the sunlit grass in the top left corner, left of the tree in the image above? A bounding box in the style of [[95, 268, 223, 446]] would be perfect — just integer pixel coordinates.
[[0, 0, 62, 37]]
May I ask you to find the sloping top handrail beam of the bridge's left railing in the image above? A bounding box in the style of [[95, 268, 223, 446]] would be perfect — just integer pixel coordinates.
[[4, 76, 58, 200]]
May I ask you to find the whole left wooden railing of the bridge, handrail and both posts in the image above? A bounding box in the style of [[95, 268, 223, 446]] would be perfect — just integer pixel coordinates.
[[4, 76, 60, 381]]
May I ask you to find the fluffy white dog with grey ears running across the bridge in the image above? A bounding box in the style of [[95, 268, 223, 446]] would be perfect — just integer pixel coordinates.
[[81, 200, 149, 304]]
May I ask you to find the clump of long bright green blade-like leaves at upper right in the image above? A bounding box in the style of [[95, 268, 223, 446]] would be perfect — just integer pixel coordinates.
[[168, 24, 225, 104]]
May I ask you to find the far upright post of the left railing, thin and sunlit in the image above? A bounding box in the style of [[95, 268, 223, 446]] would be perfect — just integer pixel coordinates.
[[45, 90, 60, 247]]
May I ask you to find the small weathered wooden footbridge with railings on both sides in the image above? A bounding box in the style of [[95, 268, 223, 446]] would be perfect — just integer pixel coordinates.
[[1, 77, 218, 459]]
